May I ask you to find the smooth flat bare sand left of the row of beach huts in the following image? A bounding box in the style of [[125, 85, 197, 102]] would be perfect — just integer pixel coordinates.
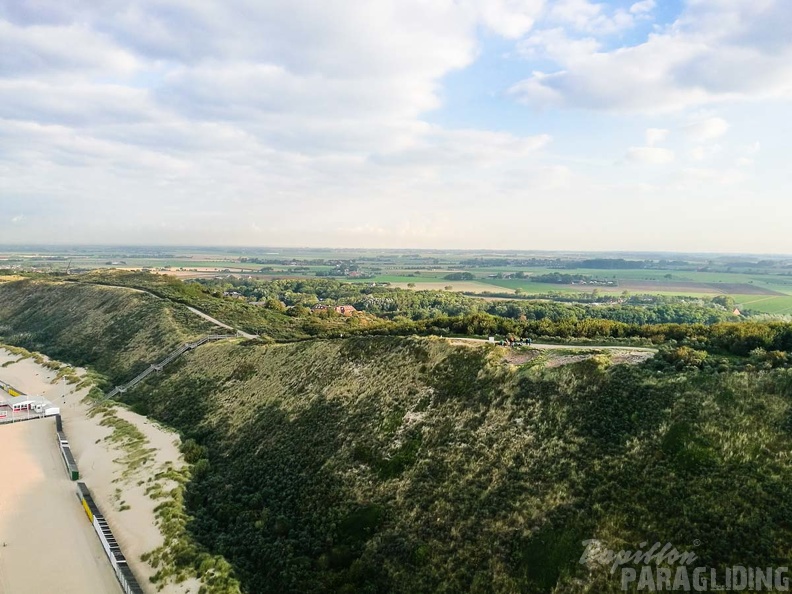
[[0, 418, 121, 594]]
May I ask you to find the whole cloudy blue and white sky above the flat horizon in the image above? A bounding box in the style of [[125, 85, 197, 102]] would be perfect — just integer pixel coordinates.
[[0, 0, 792, 253]]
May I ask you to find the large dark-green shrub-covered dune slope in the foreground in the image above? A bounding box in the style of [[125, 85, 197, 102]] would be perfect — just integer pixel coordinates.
[[128, 338, 792, 593]]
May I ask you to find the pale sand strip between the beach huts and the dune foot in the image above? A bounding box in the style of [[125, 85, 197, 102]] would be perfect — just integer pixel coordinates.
[[0, 348, 199, 594]]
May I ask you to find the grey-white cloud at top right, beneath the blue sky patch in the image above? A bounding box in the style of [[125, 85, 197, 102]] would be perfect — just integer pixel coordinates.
[[512, 0, 792, 112]]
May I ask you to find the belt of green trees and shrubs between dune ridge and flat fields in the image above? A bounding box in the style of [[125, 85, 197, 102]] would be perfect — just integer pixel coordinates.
[[54, 273, 792, 356]]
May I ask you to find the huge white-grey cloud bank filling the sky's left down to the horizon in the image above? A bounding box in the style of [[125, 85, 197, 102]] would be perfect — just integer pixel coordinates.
[[0, 0, 564, 243]]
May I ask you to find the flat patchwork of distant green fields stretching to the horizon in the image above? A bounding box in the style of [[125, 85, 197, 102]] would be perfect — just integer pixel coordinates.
[[0, 247, 792, 314]]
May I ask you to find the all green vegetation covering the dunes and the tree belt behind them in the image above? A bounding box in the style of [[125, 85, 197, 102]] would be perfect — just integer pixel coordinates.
[[0, 269, 792, 594]]
